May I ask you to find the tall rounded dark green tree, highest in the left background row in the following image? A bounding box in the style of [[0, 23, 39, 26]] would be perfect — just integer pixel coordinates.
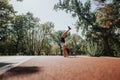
[[11, 12, 39, 54]]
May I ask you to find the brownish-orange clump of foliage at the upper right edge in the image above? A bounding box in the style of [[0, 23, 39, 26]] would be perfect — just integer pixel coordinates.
[[96, 3, 120, 29]]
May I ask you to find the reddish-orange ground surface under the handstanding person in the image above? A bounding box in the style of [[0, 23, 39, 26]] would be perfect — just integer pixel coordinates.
[[0, 56, 120, 80]]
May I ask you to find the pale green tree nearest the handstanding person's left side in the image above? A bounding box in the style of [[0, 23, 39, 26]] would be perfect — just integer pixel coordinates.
[[37, 22, 54, 55]]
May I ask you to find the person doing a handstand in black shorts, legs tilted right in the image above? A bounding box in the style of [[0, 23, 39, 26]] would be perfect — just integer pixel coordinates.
[[61, 26, 71, 57]]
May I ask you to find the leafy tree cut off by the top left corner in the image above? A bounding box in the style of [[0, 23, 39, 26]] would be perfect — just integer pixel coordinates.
[[0, 0, 15, 40]]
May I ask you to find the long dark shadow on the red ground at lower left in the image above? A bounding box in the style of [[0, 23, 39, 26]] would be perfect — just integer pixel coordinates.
[[0, 66, 42, 80]]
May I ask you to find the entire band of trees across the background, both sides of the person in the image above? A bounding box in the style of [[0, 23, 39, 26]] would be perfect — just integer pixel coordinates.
[[0, 0, 120, 56]]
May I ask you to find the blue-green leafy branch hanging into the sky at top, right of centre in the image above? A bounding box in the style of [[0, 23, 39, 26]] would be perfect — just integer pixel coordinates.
[[54, 0, 95, 35]]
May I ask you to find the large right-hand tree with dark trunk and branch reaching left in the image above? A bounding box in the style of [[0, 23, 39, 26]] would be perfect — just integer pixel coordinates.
[[54, 0, 120, 56]]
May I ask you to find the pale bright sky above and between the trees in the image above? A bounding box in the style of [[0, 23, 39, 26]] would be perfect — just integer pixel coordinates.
[[10, 0, 96, 33]]
